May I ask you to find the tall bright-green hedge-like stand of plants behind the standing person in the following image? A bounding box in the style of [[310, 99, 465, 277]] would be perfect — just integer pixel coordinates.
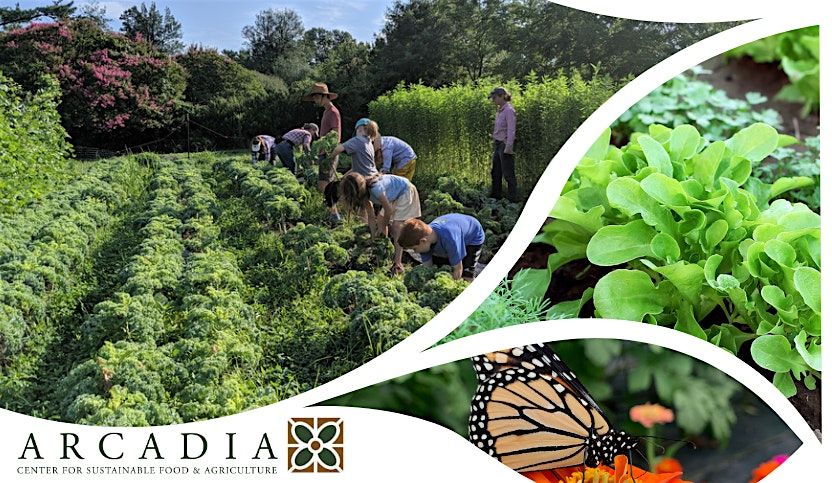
[[369, 72, 618, 192]]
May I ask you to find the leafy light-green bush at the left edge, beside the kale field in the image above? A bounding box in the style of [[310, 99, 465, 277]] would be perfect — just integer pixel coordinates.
[[0, 74, 72, 214]]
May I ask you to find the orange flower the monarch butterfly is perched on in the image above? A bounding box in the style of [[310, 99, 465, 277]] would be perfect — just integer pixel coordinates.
[[523, 455, 691, 483]]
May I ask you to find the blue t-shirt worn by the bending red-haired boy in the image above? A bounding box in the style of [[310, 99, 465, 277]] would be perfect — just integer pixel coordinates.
[[422, 213, 485, 266]]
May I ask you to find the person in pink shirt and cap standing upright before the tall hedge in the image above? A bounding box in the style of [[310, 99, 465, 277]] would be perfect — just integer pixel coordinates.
[[488, 87, 517, 201]]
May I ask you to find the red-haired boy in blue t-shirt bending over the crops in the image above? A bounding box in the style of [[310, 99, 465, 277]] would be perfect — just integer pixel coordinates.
[[398, 213, 485, 280]]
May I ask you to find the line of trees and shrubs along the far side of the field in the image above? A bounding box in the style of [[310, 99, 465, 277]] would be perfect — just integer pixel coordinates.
[[0, 0, 727, 150]]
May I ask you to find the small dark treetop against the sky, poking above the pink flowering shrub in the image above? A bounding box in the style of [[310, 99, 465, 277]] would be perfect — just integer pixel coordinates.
[[119, 2, 185, 54]]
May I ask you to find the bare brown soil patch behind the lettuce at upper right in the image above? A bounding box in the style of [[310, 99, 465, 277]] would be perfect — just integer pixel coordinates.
[[698, 56, 820, 139]]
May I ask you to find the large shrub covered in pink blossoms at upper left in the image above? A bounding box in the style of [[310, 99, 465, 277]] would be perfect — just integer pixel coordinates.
[[0, 20, 185, 146]]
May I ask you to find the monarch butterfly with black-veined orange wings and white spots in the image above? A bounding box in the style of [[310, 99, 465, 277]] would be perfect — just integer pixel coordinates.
[[468, 344, 638, 472]]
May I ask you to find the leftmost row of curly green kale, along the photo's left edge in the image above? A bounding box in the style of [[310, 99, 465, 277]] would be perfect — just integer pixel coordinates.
[[0, 158, 146, 364]]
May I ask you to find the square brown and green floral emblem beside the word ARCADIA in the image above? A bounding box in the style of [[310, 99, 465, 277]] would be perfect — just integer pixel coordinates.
[[288, 418, 344, 473]]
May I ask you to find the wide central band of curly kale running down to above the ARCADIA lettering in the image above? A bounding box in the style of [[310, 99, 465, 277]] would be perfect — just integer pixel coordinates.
[[56, 161, 284, 426]]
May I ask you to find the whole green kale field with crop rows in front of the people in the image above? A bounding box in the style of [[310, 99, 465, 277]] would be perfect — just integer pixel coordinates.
[[0, 152, 519, 426]]
